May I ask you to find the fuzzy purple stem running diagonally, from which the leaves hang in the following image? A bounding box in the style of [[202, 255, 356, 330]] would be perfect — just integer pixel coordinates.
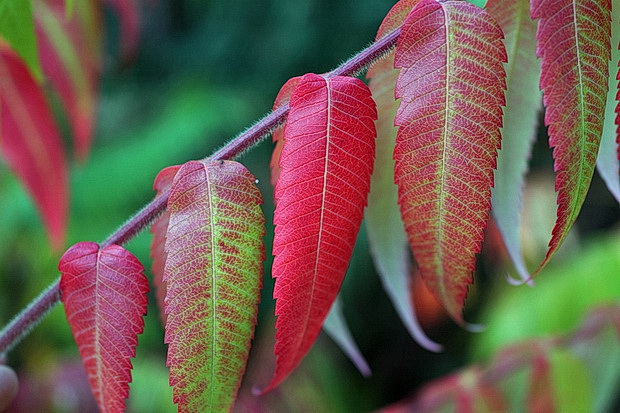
[[0, 28, 400, 355]]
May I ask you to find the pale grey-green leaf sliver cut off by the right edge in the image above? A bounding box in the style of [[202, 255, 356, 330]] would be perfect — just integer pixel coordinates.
[[596, 6, 620, 202]]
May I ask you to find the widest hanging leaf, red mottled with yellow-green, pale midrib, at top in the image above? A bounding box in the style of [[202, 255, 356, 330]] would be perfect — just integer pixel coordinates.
[[394, 0, 506, 322]]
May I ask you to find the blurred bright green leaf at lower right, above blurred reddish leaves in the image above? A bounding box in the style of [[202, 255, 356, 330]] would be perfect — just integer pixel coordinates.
[[472, 231, 620, 359]]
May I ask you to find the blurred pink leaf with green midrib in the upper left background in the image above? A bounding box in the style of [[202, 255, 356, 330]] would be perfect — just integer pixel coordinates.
[[34, 0, 102, 159]]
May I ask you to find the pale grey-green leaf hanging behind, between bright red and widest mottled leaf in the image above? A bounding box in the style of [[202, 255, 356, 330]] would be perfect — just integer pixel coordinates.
[[365, 0, 441, 351]]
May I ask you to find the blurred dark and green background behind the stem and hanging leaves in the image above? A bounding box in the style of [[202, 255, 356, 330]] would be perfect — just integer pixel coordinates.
[[0, 0, 620, 412]]
